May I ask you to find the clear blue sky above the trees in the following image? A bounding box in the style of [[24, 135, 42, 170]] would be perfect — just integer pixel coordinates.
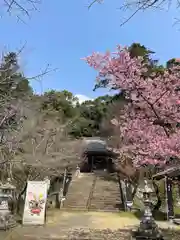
[[0, 0, 180, 97]]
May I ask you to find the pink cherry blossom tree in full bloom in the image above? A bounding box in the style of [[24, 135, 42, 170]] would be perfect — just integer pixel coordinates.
[[84, 46, 180, 166]]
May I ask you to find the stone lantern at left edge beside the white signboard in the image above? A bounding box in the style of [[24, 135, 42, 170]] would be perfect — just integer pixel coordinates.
[[0, 182, 16, 230]]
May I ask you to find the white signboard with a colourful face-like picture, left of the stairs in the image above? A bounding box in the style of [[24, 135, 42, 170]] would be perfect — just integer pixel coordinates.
[[23, 181, 48, 225]]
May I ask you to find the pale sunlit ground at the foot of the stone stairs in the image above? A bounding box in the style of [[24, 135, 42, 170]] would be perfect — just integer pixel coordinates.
[[0, 211, 180, 240]]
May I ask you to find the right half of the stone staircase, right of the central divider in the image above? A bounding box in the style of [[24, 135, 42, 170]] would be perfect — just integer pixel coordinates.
[[88, 174, 121, 212]]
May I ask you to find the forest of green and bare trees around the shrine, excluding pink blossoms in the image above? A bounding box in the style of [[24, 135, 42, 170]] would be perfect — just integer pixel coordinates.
[[0, 43, 176, 195]]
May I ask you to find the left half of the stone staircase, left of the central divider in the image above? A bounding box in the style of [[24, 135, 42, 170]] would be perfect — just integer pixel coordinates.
[[62, 173, 95, 211]]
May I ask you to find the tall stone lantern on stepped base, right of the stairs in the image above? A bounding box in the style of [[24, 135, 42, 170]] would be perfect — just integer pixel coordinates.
[[132, 180, 163, 240]]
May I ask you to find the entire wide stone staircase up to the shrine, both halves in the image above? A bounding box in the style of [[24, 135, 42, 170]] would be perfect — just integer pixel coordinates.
[[63, 174, 121, 212]]
